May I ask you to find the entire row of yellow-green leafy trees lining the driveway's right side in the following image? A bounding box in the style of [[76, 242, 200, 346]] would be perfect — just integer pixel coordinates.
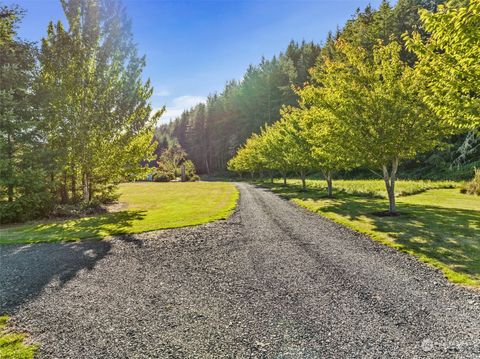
[[229, 0, 480, 214]]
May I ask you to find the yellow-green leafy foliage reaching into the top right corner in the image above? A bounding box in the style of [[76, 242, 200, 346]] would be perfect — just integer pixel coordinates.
[[408, 0, 480, 131]]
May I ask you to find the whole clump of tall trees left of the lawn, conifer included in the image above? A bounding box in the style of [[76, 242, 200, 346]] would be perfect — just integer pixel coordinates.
[[0, 0, 161, 223]]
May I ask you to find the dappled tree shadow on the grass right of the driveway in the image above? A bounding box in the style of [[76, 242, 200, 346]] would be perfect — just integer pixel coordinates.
[[262, 185, 480, 284]]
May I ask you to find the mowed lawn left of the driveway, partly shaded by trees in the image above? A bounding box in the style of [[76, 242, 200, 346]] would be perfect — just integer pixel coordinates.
[[0, 182, 238, 244]]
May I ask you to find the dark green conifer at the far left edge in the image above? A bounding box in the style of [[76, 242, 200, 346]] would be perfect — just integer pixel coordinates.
[[0, 7, 51, 223]]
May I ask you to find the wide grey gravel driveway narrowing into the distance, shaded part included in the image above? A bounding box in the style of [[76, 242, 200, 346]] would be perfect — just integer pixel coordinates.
[[0, 184, 480, 359]]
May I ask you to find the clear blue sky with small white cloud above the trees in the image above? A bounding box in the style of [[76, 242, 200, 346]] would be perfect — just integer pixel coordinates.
[[8, 0, 380, 122]]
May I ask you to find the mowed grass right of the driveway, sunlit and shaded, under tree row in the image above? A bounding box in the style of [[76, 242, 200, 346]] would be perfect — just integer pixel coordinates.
[[258, 181, 480, 286]]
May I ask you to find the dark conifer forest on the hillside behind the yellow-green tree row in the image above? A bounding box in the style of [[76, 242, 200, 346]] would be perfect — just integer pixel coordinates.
[[156, 0, 480, 177]]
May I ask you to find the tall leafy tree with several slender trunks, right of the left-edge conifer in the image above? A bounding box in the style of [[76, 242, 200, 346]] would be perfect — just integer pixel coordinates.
[[37, 0, 161, 202]]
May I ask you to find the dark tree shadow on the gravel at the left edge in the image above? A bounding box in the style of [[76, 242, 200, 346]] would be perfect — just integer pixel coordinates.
[[0, 241, 111, 314]]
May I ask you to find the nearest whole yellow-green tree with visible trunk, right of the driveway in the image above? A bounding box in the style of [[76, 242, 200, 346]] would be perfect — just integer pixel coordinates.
[[314, 41, 444, 213]]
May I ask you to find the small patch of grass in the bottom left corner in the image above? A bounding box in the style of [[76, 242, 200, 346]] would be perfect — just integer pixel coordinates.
[[0, 315, 37, 359]]
